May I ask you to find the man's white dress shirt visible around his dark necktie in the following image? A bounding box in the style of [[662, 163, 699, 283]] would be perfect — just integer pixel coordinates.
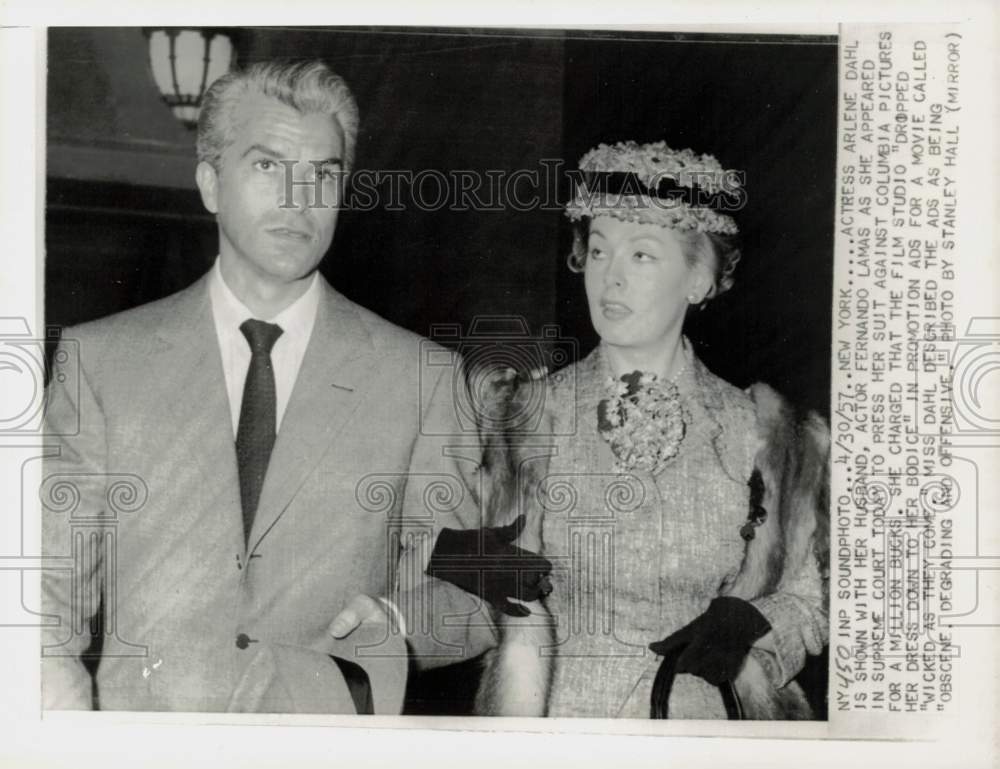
[[208, 259, 320, 438]]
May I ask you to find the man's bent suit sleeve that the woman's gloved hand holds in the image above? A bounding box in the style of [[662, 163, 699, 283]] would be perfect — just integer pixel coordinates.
[[394, 352, 497, 669]]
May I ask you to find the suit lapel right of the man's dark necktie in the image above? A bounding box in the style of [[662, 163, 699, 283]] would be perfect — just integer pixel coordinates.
[[248, 278, 375, 553]]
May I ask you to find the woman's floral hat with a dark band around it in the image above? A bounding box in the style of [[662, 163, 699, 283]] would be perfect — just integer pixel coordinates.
[[566, 141, 746, 235]]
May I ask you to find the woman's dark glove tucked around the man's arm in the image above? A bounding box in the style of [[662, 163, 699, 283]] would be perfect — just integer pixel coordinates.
[[426, 514, 552, 617]]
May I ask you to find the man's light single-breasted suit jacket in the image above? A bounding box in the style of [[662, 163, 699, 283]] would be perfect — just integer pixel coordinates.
[[41, 278, 495, 711]]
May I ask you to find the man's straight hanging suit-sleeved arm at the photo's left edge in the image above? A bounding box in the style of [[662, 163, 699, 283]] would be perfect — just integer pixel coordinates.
[[39, 342, 107, 709]]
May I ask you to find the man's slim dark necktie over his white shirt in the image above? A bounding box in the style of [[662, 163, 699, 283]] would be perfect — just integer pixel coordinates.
[[236, 320, 282, 541]]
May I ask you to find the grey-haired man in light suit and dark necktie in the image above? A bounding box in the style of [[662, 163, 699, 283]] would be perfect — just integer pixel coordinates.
[[42, 62, 516, 711]]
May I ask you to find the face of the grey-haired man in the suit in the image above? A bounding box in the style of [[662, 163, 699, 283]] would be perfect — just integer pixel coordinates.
[[197, 94, 344, 286]]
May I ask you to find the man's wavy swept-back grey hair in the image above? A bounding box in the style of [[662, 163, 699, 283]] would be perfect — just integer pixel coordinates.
[[198, 61, 358, 172]]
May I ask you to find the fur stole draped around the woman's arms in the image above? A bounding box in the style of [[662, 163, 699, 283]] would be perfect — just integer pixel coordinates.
[[475, 368, 830, 720]]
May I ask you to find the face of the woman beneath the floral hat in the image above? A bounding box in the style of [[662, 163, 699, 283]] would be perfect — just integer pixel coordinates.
[[584, 216, 710, 355]]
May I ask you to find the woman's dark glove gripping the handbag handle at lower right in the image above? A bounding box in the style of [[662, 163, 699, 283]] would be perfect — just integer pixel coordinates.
[[649, 596, 771, 718]]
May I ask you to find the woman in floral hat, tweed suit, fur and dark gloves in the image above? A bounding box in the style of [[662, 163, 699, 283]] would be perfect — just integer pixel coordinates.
[[468, 143, 828, 718]]
